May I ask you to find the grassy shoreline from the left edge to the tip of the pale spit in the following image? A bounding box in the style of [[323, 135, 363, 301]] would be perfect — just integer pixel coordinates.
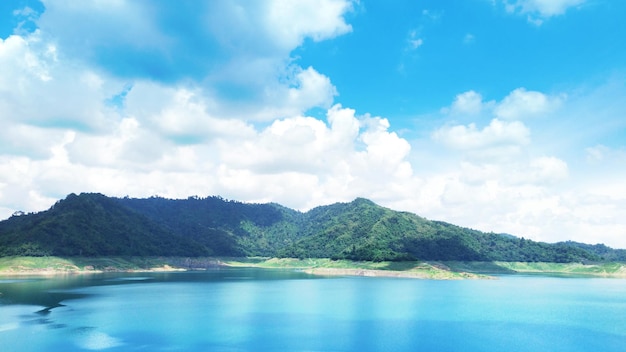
[[0, 257, 486, 280]]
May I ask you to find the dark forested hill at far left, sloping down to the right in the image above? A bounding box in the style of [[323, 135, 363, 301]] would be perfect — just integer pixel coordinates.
[[0, 194, 207, 256]]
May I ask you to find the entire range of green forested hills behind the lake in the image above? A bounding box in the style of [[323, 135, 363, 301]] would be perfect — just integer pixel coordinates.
[[0, 193, 626, 262]]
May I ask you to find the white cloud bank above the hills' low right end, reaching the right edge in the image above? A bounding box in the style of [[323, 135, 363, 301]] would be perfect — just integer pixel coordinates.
[[414, 80, 626, 248]]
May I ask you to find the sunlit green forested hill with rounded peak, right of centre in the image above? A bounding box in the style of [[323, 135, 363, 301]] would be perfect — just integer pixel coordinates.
[[278, 199, 601, 262]]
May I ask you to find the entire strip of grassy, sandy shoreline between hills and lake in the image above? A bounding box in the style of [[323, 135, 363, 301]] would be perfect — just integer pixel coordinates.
[[0, 257, 626, 280]]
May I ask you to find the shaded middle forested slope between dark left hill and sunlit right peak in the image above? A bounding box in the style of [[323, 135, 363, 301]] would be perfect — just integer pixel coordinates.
[[118, 197, 301, 256]]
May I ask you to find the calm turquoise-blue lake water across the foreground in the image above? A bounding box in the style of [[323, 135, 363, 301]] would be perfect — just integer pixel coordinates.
[[0, 269, 626, 352]]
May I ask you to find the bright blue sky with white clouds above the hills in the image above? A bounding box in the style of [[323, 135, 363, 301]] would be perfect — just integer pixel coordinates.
[[0, 0, 626, 248]]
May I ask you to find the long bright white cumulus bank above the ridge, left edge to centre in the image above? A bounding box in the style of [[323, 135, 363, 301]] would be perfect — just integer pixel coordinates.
[[0, 105, 412, 216]]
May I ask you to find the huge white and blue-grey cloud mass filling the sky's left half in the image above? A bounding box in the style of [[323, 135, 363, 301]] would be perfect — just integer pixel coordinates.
[[0, 1, 354, 216]]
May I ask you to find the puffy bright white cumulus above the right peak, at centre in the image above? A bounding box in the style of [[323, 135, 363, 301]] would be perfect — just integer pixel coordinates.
[[217, 105, 411, 194]]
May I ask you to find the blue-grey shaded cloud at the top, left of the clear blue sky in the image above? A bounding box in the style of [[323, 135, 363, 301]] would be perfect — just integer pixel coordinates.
[[29, 0, 352, 121]]
